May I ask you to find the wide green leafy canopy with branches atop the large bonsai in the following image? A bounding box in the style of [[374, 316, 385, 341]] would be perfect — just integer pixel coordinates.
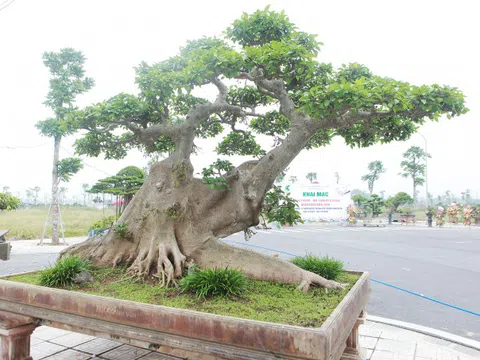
[[70, 7, 467, 191]]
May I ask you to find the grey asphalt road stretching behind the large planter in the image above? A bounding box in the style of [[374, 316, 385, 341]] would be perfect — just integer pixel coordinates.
[[0, 224, 480, 341]]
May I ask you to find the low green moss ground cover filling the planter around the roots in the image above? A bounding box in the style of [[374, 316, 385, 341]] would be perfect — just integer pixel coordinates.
[[8, 268, 360, 327]]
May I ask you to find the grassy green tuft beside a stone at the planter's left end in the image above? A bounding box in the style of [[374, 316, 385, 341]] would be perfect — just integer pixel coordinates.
[[40, 256, 91, 287]]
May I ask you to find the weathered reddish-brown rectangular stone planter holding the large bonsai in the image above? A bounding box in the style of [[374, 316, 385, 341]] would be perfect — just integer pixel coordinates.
[[0, 273, 370, 360]]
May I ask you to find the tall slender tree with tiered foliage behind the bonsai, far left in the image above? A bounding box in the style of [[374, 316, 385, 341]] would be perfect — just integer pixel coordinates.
[[36, 48, 94, 245]]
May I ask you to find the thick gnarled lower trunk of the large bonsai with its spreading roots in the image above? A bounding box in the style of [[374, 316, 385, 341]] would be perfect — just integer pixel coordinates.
[[64, 157, 339, 290]]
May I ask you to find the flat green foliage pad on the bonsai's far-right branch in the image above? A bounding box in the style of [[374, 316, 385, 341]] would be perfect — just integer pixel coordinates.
[[299, 77, 468, 147]]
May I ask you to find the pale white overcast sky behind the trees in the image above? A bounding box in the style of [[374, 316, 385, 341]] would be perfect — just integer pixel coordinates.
[[0, 0, 480, 199]]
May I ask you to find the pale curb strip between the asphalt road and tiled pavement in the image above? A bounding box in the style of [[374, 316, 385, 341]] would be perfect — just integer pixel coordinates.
[[367, 314, 480, 351]]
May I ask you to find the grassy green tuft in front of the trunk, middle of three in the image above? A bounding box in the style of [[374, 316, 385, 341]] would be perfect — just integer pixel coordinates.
[[180, 268, 247, 299]]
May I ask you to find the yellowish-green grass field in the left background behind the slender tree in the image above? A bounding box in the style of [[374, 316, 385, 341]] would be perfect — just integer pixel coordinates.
[[0, 206, 115, 240]]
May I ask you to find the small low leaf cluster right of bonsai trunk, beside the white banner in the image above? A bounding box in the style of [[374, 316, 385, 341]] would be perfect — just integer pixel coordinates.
[[261, 185, 303, 226]]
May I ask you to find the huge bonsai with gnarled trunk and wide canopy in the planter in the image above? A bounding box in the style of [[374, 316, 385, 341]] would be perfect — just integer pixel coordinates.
[[64, 8, 467, 290]]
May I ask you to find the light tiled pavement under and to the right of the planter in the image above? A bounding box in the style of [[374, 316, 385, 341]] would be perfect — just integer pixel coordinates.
[[31, 321, 480, 360]]
